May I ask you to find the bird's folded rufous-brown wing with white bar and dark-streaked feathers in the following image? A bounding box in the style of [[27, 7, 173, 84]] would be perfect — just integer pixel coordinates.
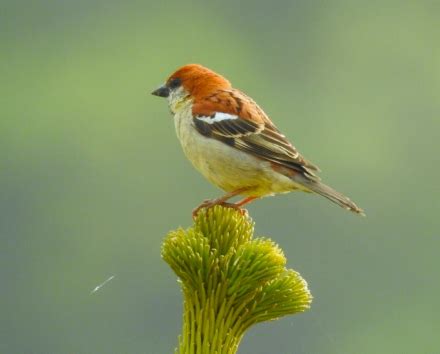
[[193, 90, 319, 180]]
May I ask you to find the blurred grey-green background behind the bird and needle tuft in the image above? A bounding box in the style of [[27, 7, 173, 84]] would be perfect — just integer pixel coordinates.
[[0, 0, 440, 354]]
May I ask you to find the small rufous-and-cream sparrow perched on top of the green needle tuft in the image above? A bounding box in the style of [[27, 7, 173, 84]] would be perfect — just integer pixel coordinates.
[[152, 64, 365, 217]]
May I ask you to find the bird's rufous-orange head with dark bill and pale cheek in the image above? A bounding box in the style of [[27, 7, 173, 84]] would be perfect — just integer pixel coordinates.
[[152, 64, 231, 111]]
